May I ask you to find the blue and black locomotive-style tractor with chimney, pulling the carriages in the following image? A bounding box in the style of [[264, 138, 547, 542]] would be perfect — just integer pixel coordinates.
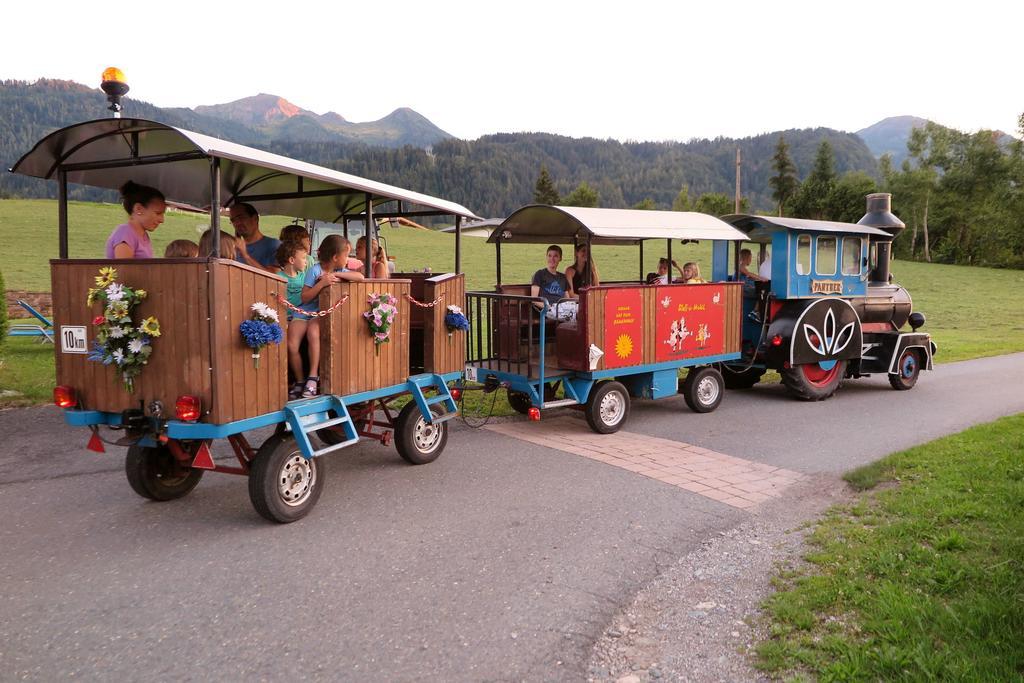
[[714, 194, 936, 400]]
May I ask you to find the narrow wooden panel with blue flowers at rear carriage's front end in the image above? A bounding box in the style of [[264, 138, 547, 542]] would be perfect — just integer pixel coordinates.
[[414, 273, 467, 374]]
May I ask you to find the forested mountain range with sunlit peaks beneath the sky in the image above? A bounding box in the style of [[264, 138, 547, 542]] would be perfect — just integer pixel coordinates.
[[0, 79, 983, 215]]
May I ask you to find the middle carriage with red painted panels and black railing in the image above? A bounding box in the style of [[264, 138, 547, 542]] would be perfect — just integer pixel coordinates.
[[466, 206, 746, 433]]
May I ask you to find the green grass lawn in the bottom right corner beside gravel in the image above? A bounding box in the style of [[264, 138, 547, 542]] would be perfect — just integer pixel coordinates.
[[758, 415, 1024, 681]]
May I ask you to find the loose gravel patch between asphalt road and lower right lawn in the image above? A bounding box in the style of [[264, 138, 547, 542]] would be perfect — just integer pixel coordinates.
[[587, 475, 854, 683]]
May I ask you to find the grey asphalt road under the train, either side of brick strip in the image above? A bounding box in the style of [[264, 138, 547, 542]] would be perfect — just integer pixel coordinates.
[[0, 354, 1024, 680]]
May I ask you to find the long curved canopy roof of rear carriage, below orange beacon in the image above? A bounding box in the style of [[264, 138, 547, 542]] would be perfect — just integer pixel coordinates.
[[11, 119, 477, 221]]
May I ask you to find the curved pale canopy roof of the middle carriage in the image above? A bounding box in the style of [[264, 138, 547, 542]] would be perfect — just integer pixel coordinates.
[[487, 204, 746, 245]]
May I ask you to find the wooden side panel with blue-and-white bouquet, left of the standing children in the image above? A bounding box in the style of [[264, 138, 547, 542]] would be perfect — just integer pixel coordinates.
[[209, 259, 288, 424]]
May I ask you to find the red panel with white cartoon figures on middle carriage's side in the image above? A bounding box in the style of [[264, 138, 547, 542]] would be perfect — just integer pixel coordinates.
[[654, 285, 725, 362]]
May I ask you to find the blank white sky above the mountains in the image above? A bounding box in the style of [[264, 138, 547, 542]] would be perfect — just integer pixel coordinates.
[[0, 0, 1024, 140]]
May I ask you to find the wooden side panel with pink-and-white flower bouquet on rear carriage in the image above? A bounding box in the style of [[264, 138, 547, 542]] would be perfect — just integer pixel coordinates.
[[319, 280, 411, 395]]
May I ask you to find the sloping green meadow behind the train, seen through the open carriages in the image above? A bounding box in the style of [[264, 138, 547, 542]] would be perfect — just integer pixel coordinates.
[[0, 200, 1024, 404]]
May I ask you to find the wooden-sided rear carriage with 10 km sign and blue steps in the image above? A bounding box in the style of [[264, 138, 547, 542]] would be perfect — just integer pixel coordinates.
[[11, 119, 473, 522]]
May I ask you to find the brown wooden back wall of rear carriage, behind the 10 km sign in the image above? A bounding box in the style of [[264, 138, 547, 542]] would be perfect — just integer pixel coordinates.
[[50, 259, 213, 413]]
